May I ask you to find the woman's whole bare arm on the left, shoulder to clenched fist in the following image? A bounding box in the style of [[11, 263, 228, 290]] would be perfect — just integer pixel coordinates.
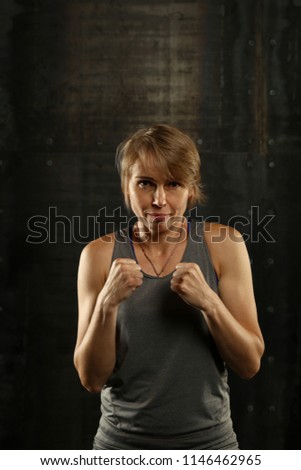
[[74, 237, 142, 393]]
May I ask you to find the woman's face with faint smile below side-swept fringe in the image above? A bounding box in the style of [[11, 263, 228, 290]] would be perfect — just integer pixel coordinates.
[[128, 160, 193, 232]]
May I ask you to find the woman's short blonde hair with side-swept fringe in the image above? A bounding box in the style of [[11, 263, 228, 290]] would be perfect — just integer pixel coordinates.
[[116, 124, 205, 208]]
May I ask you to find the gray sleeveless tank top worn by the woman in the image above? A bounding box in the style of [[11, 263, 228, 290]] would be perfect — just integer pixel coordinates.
[[95, 221, 236, 449]]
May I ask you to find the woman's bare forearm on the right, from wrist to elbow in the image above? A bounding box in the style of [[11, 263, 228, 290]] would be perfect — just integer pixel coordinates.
[[202, 293, 264, 379]]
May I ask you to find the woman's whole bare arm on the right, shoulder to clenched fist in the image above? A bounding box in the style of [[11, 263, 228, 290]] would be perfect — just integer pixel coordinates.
[[172, 224, 264, 379]]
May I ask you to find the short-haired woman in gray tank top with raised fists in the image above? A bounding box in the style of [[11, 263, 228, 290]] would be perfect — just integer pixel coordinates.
[[74, 125, 264, 449]]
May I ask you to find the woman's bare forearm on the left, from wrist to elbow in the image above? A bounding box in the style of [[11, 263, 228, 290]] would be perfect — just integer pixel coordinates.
[[74, 294, 117, 393]]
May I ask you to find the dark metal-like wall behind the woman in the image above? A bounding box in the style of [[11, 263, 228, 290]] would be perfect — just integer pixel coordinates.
[[0, 0, 301, 449]]
